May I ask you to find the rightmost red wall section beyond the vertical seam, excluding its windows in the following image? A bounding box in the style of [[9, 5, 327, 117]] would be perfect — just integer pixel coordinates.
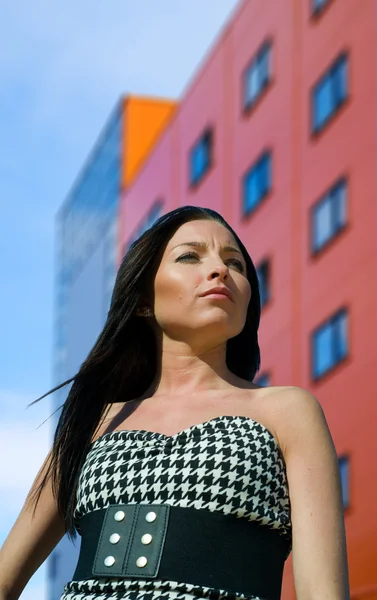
[[295, 0, 377, 600]]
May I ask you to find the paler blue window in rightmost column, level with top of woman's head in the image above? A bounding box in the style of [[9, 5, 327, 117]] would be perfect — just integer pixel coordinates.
[[312, 178, 348, 252]]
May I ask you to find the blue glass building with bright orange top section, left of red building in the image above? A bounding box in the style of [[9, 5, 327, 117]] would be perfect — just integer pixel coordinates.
[[48, 97, 175, 600]]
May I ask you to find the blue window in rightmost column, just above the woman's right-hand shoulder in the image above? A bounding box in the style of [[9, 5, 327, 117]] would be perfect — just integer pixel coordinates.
[[312, 309, 348, 379]]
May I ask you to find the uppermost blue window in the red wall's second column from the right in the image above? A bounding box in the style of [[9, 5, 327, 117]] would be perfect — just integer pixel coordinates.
[[243, 42, 272, 110]]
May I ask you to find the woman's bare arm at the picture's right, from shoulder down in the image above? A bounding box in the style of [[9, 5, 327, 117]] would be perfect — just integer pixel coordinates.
[[279, 387, 350, 600]]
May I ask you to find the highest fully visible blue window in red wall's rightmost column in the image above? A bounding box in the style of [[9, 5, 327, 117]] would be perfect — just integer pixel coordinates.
[[312, 54, 348, 133]]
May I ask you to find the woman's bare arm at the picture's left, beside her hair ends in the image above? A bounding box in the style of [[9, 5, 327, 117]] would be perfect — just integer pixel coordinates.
[[0, 455, 65, 600]]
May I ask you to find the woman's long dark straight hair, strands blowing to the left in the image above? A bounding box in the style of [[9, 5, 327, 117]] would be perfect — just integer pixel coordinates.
[[29, 206, 260, 541]]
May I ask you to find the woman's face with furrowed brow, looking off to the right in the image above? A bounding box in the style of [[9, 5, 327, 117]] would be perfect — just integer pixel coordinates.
[[153, 220, 251, 349]]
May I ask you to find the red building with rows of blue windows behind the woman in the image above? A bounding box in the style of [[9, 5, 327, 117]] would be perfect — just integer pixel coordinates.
[[50, 0, 377, 600]]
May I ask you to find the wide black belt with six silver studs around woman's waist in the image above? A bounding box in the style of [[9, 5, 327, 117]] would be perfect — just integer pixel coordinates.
[[73, 504, 290, 600]]
